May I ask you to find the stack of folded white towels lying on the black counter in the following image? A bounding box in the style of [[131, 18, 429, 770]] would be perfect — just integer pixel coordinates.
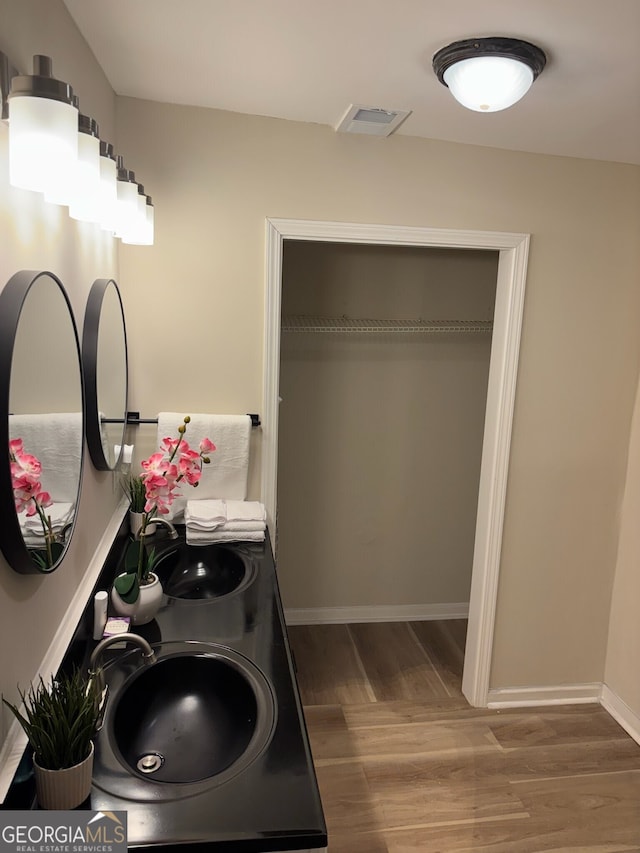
[[184, 499, 267, 545]]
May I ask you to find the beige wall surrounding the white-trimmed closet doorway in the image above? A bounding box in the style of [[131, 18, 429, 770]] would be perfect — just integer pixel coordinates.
[[117, 98, 640, 687]]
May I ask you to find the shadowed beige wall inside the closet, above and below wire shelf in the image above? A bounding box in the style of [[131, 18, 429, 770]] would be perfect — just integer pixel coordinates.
[[278, 241, 498, 612]]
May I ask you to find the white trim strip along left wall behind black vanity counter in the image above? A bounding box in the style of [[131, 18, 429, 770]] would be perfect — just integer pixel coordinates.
[[0, 498, 128, 803]]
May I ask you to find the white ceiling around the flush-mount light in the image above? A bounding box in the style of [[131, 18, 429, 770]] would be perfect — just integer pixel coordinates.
[[65, 0, 640, 164]]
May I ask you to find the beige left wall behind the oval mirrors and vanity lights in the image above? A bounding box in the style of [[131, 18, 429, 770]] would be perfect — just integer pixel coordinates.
[[0, 0, 118, 745]]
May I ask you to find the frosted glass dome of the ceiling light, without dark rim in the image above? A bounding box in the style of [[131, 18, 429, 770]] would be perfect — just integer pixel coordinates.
[[444, 56, 533, 113]]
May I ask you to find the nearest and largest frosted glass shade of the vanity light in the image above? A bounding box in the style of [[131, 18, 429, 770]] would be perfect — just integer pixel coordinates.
[[9, 96, 78, 193]]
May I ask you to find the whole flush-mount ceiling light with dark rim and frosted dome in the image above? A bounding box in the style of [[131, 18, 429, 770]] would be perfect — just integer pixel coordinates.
[[433, 36, 547, 113]]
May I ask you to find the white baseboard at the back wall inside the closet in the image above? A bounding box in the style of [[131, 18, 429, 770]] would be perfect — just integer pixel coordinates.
[[284, 601, 469, 625]]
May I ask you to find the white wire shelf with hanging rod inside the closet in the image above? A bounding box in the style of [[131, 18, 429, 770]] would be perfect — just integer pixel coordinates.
[[281, 315, 493, 333]]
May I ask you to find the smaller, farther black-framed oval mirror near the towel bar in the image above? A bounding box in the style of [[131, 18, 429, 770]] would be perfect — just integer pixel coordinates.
[[82, 278, 128, 471]]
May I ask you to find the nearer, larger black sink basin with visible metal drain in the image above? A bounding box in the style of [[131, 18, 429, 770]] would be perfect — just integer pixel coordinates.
[[109, 647, 274, 785]]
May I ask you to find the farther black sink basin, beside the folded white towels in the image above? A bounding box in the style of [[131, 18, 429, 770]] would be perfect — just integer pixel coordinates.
[[154, 544, 253, 600]]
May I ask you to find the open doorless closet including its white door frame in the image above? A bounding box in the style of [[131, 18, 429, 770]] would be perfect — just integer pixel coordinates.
[[263, 220, 528, 706]]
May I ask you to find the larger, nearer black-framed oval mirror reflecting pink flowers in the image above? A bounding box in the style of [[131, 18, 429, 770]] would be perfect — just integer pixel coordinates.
[[0, 270, 84, 574]]
